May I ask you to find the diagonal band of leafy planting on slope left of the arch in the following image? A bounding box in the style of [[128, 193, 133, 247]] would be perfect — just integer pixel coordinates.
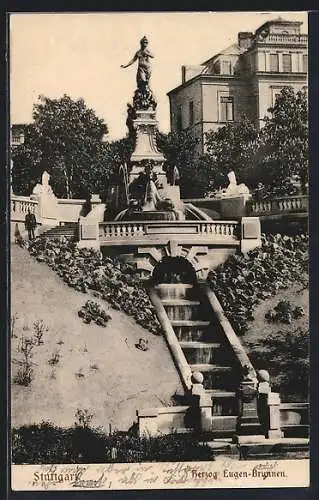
[[28, 237, 161, 334]]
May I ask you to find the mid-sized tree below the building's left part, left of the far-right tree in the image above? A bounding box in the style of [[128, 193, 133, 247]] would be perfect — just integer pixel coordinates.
[[202, 117, 259, 189]]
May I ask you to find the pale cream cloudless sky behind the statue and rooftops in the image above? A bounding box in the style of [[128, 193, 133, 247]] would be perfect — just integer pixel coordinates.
[[9, 11, 308, 140]]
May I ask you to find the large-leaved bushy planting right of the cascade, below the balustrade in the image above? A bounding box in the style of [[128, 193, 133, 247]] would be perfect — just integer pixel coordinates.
[[208, 234, 308, 335]]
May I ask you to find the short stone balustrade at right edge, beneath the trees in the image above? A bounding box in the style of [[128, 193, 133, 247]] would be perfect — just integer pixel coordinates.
[[248, 195, 308, 216]]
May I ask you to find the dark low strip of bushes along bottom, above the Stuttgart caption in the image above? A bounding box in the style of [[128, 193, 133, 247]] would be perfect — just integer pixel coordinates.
[[12, 422, 214, 464]]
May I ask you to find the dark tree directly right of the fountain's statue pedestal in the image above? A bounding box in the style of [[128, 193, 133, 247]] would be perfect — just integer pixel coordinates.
[[157, 131, 208, 198]]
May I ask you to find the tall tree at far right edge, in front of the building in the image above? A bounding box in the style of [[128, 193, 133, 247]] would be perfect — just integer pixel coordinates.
[[260, 87, 308, 195]]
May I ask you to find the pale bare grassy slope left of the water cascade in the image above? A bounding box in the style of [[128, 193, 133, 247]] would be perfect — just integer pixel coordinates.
[[11, 245, 181, 430]]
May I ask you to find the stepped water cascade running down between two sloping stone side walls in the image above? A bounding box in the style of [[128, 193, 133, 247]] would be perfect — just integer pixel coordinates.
[[155, 283, 241, 437]]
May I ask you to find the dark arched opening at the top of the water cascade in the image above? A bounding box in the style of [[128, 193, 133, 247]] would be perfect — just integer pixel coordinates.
[[153, 257, 197, 285]]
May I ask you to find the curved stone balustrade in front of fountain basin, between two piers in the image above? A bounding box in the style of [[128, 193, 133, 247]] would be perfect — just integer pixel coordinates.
[[99, 221, 239, 241]]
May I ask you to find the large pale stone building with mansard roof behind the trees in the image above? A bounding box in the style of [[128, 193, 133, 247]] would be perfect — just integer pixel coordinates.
[[168, 18, 308, 153]]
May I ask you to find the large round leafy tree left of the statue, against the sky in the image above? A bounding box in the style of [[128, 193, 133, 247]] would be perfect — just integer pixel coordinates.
[[12, 94, 109, 198]]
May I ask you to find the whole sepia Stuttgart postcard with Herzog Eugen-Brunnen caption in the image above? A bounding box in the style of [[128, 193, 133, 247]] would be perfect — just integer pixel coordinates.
[[8, 11, 310, 491]]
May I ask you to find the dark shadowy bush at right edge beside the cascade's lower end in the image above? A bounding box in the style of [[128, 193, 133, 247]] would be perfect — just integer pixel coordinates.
[[250, 329, 309, 401]]
